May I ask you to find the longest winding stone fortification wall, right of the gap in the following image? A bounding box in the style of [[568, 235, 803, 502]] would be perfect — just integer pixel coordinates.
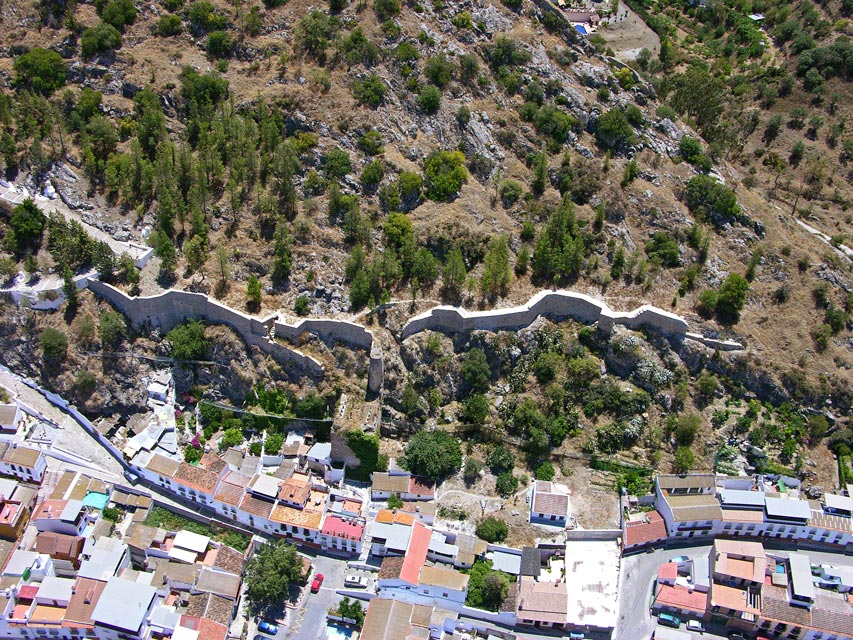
[[401, 291, 743, 351]]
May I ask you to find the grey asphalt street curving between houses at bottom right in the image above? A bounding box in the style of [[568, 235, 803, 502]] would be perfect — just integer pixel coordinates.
[[613, 545, 853, 640]]
